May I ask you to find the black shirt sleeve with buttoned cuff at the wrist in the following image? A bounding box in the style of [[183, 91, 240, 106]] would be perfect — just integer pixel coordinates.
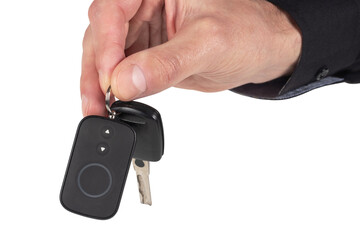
[[232, 0, 360, 99]]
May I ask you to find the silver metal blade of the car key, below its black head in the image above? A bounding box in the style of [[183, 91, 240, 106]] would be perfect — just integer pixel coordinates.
[[132, 158, 152, 206]]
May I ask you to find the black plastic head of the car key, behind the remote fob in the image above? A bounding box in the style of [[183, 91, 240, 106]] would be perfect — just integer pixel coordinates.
[[111, 101, 164, 162]]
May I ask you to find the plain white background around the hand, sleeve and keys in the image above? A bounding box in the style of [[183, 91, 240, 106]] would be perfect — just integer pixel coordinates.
[[0, 0, 360, 240]]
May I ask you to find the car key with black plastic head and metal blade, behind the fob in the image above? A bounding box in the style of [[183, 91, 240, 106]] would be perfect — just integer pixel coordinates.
[[111, 101, 164, 206]]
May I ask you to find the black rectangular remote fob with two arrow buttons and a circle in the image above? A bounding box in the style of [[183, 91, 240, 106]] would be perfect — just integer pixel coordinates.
[[60, 116, 136, 219]]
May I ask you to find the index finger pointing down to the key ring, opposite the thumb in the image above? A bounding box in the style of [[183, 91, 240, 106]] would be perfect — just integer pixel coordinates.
[[89, 0, 141, 93]]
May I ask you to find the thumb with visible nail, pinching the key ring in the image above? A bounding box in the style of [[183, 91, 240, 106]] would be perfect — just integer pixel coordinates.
[[111, 22, 213, 101]]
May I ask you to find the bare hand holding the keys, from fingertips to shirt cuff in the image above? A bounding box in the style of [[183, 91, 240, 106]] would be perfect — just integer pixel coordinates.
[[80, 0, 301, 116]]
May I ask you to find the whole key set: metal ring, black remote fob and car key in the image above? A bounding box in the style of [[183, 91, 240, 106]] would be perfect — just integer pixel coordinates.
[[60, 87, 164, 219]]
